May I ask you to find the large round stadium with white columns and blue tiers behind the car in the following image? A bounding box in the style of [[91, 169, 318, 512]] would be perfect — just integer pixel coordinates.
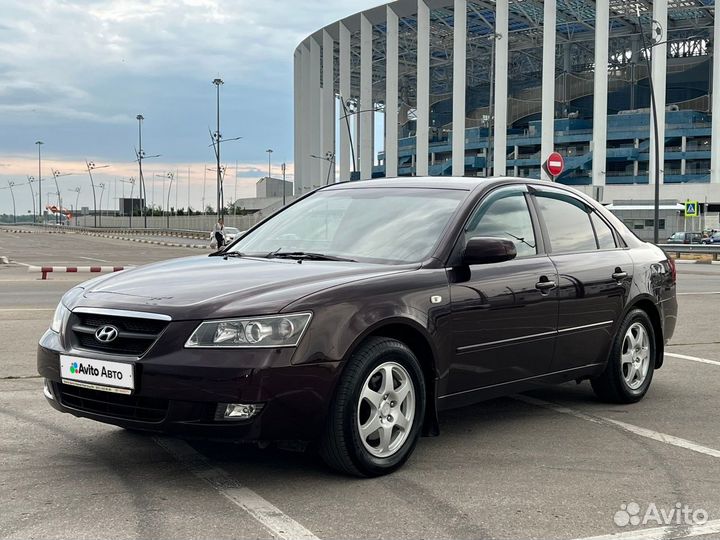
[[294, 0, 720, 238]]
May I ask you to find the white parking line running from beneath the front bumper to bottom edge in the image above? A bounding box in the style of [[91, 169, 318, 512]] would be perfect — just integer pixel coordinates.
[[153, 437, 319, 540]]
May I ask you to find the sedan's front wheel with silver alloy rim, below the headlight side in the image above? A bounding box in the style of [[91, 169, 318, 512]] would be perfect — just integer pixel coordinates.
[[319, 337, 426, 477]]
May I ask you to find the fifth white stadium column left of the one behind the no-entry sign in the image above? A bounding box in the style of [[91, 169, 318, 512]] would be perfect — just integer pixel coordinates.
[[357, 13, 375, 180]]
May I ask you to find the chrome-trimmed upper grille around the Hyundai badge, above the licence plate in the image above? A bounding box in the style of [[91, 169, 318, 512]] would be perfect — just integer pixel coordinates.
[[69, 313, 168, 356]]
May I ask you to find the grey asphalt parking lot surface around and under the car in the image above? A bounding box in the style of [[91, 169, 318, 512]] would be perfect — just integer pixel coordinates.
[[0, 230, 720, 539]]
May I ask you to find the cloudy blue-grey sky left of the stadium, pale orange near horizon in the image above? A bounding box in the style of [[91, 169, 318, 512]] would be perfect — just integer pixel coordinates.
[[0, 0, 381, 213]]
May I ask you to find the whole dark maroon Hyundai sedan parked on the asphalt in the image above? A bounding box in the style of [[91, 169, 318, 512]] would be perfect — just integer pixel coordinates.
[[38, 178, 677, 476]]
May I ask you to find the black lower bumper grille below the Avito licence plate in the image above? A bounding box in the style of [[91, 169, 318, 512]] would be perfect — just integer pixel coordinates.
[[57, 383, 168, 422]]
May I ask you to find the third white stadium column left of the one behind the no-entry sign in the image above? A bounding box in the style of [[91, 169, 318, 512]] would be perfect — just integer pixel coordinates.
[[415, 0, 430, 176]]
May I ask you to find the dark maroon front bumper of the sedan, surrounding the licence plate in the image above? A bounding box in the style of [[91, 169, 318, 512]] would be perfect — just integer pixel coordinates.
[[37, 331, 339, 441]]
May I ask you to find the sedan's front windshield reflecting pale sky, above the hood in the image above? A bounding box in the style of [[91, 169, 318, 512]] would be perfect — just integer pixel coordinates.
[[229, 187, 467, 264]]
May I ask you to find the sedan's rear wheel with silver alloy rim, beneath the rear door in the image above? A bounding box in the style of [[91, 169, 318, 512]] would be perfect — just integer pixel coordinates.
[[590, 309, 657, 403]]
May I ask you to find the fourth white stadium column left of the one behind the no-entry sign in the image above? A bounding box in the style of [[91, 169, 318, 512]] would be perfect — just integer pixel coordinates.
[[385, 5, 399, 178]]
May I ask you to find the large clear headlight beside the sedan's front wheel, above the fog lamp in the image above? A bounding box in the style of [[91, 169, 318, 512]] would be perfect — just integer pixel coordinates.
[[185, 313, 312, 348]]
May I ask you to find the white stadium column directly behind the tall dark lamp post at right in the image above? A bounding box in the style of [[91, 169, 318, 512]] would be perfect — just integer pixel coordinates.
[[648, 0, 668, 184]]
